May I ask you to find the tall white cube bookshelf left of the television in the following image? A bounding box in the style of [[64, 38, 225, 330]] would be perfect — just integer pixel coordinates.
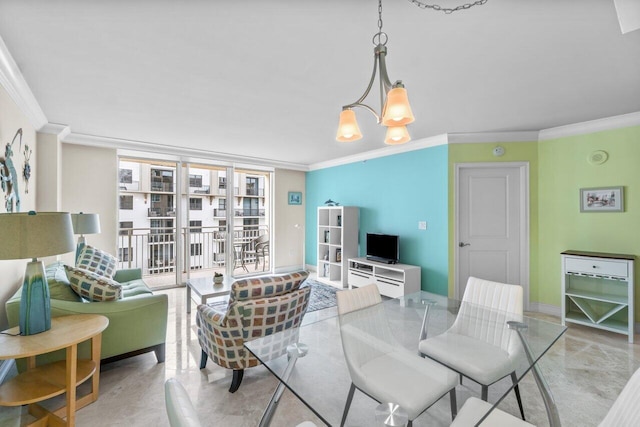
[[317, 206, 359, 288]]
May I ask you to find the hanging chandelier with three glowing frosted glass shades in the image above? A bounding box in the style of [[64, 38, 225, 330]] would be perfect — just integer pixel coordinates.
[[336, 0, 415, 144]]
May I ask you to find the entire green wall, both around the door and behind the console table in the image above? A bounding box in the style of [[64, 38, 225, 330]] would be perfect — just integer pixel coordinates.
[[449, 126, 640, 320]]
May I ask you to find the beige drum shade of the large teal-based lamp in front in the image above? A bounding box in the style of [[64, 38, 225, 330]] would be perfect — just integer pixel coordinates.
[[0, 211, 75, 259]]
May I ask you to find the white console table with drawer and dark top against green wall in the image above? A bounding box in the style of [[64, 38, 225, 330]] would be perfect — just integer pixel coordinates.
[[561, 251, 635, 343]]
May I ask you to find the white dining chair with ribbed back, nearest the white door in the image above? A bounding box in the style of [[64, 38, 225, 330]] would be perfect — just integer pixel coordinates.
[[418, 277, 525, 420]]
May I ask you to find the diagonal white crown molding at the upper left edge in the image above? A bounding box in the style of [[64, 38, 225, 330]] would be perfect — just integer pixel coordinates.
[[0, 37, 47, 130]]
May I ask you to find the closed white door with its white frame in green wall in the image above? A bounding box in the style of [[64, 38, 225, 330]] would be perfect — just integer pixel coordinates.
[[455, 163, 529, 308]]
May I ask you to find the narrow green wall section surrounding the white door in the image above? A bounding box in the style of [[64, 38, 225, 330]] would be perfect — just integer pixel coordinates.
[[449, 141, 540, 305]]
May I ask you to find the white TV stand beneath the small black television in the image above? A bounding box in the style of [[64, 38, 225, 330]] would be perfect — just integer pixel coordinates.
[[348, 258, 420, 298]]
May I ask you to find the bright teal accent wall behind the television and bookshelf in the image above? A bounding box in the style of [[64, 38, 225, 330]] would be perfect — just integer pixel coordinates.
[[305, 145, 449, 295]]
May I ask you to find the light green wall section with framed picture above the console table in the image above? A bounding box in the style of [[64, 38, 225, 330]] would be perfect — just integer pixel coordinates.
[[531, 126, 640, 312]]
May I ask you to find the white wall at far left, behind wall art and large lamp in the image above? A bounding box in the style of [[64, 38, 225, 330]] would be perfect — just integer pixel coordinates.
[[0, 86, 38, 330]]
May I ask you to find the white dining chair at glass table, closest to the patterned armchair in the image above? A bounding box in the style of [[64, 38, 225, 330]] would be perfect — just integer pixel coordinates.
[[336, 284, 457, 427]]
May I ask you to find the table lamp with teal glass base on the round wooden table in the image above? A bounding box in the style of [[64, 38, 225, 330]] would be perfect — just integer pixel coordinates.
[[0, 211, 74, 335]]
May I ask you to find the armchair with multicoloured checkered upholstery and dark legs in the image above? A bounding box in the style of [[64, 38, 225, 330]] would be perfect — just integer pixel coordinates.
[[196, 271, 311, 393]]
